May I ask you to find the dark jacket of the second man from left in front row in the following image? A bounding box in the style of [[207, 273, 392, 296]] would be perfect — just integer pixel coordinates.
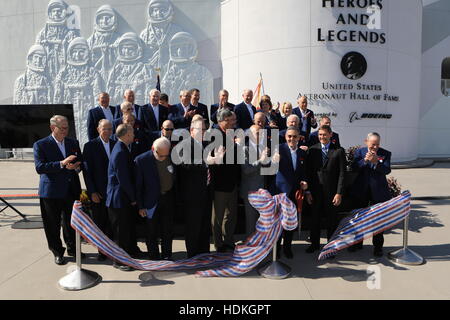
[[83, 137, 116, 199]]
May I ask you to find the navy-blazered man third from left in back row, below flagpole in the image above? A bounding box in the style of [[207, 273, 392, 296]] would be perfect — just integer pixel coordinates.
[[138, 89, 169, 136]]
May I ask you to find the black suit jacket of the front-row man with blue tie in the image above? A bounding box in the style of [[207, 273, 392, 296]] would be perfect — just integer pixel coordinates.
[[306, 143, 346, 203]]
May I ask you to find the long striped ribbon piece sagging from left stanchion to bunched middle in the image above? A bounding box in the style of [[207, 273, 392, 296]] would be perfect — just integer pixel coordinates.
[[71, 189, 297, 277]]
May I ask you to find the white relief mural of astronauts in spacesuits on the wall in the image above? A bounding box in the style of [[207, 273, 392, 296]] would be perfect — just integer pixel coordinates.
[[14, 0, 213, 145]]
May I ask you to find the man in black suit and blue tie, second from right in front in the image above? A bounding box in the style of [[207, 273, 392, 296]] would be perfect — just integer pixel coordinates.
[[306, 126, 345, 253]]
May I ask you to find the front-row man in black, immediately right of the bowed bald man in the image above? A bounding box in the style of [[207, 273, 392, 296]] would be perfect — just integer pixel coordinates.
[[173, 120, 212, 258]]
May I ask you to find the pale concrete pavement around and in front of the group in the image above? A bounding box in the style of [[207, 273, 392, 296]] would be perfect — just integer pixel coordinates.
[[0, 162, 450, 300]]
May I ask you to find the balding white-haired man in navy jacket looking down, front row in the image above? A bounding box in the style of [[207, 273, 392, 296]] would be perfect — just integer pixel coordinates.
[[134, 137, 175, 260]]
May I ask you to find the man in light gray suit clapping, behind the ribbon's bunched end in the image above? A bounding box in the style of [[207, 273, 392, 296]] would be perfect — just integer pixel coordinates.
[[240, 125, 269, 236]]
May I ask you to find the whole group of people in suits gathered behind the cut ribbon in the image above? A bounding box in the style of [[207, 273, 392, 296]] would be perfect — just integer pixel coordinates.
[[34, 89, 390, 271]]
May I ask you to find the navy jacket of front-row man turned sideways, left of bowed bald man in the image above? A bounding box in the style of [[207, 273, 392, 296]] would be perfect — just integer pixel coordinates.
[[106, 140, 136, 209]]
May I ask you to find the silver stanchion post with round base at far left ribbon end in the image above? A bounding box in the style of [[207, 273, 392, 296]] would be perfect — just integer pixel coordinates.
[[58, 232, 102, 291]]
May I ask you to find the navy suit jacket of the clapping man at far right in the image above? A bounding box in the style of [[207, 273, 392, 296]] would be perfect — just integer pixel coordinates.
[[350, 148, 392, 203]]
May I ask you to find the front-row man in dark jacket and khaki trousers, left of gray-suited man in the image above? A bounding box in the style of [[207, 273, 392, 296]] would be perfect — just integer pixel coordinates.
[[208, 109, 241, 252]]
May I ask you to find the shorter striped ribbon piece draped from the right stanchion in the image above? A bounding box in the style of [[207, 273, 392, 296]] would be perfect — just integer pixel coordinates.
[[319, 191, 411, 260]]
